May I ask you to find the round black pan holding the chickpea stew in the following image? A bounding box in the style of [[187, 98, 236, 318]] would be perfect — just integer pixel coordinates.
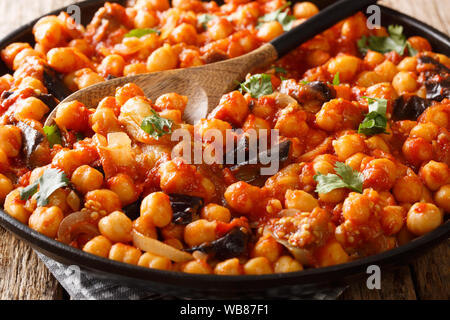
[[0, 0, 450, 298]]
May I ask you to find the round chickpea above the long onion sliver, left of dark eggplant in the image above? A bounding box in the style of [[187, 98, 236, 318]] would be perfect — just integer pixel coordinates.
[[141, 192, 173, 228]]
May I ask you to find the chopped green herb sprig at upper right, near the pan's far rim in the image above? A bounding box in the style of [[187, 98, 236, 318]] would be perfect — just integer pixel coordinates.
[[358, 25, 417, 56]]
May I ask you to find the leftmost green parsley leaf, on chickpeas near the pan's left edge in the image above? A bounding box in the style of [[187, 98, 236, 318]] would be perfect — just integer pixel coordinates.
[[20, 168, 69, 207]]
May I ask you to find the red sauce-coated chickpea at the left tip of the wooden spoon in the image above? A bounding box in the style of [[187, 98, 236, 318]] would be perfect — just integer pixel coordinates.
[[55, 101, 88, 131]]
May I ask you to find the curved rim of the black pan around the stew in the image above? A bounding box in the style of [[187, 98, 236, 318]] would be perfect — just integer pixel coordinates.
[[0, 0, 450, 291]]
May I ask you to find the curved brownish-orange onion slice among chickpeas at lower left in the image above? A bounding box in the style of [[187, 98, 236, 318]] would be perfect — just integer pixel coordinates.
[[58, 211, 100, 244]]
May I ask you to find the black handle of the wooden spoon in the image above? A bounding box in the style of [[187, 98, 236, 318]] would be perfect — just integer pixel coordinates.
[[270, 0, 377, 57]]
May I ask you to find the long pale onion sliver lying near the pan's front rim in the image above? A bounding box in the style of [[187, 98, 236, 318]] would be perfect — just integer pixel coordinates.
[[133, 230, 194, 262]]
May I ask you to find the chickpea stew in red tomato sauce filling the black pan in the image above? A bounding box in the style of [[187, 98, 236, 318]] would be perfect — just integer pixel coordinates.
[[0, 0, 450, 275]]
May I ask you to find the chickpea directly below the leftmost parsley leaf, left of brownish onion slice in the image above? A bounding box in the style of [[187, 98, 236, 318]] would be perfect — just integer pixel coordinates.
[[28, 206, 64, 238]]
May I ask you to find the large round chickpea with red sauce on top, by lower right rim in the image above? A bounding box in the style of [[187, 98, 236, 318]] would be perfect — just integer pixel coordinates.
[[406, 203, 443, 236]]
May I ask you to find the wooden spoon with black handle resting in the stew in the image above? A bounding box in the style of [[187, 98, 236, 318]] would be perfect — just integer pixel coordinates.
[[45, 0, 377, 126]]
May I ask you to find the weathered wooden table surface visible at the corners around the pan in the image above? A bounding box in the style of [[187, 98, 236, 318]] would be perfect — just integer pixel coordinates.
[[0, 0, 450, 300]]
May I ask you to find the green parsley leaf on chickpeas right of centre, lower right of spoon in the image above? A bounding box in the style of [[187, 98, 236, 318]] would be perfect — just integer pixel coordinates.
[[314, 162, 364, 193]]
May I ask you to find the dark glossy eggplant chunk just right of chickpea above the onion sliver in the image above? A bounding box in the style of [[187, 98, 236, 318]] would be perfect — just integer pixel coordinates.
[[169, 194, 204, 225]]
